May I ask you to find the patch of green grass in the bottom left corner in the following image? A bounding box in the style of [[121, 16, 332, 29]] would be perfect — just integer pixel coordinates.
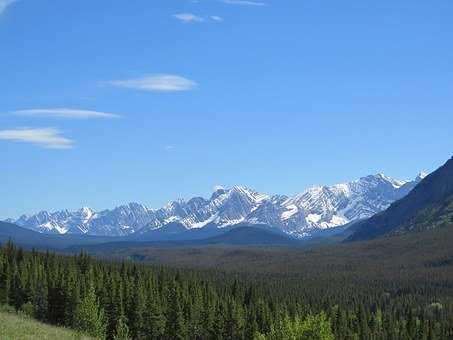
[[0, 310, 93, 340]]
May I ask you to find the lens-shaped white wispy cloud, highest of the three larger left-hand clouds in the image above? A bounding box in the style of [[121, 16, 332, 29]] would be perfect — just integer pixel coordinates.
[[103, 74, 197, 92]]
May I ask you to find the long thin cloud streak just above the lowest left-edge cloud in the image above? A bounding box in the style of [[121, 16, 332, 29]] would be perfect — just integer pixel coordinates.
[[13, 108, 120, 119]]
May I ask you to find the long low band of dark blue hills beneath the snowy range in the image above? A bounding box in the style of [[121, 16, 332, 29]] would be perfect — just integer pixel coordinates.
[[0, 221, 300, 250]]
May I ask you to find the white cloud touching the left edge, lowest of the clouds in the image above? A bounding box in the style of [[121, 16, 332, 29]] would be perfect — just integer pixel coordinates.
[[0, 128, 74, 149]]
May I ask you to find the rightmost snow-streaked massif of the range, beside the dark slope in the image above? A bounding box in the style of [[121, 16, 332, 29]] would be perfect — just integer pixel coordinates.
[[247, 174, 421, 236]]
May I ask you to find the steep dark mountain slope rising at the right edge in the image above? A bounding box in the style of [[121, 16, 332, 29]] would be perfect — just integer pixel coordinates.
[[348, 158, 453, 241]]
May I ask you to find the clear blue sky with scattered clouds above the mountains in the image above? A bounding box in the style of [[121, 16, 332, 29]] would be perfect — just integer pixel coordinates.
[[0, 0, 453, 218]]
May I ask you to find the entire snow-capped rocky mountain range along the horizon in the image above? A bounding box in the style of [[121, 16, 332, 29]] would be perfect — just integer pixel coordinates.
[[10, 174, 425, 237]]
